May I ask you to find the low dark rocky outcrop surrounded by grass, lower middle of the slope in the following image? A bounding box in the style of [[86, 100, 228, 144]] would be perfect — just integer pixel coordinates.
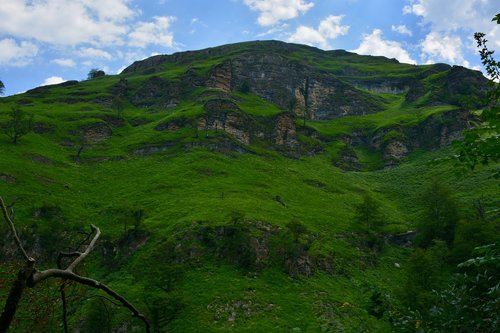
[[150, 220, 324, 277]]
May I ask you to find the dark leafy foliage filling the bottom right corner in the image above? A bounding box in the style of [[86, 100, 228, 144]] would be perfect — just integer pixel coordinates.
[[394, 244, 500, 333]]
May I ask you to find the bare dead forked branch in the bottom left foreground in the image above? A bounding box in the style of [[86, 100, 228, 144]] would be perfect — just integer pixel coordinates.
[[0, 197, 150, 333]]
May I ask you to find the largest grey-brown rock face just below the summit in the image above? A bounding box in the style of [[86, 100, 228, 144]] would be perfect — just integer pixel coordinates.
[[206, 53, 381, 120]]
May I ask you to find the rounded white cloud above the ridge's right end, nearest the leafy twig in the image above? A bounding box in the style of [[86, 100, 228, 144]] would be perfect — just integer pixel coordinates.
[[420, 32, 469, 66]]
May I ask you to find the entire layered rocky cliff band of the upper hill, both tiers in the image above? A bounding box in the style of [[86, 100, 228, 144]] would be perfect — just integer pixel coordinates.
[[113, 41, 487, 169]]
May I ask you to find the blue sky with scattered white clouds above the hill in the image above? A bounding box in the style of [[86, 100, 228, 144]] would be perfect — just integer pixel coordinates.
[[0, 0, 500, 95]]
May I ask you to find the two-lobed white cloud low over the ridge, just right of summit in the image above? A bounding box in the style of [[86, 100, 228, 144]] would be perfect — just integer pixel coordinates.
[[288, 15, 349, 49]]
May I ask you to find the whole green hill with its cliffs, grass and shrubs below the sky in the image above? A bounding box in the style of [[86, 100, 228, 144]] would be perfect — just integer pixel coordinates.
[[0, 42, 500, 332]]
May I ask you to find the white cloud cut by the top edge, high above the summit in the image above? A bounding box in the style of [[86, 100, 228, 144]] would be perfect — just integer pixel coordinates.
[[245, 0, 314, 26]]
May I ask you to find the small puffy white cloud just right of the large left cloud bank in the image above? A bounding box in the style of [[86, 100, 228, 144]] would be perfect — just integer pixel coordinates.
[[128, 16, 176, 48]]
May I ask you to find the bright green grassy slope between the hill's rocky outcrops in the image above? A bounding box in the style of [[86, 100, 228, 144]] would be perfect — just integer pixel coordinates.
[[0, 48, 498, 332]]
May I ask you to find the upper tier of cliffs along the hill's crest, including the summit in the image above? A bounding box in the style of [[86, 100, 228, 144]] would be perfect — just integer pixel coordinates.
[[122, 41, 487, 120]]
